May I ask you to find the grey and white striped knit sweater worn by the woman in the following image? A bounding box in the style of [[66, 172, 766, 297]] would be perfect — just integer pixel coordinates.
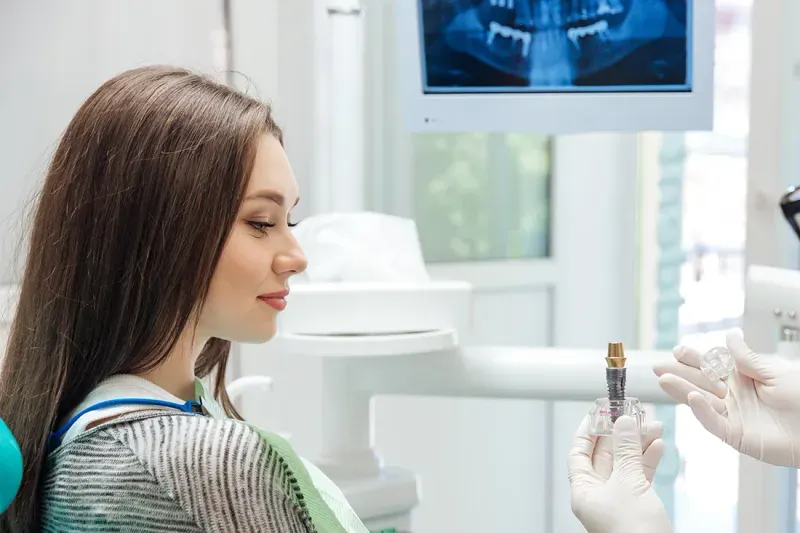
[[41, 376, 314, 533]]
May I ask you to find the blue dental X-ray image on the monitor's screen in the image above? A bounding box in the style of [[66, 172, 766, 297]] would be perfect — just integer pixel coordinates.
[[417, 0, 692, 94]]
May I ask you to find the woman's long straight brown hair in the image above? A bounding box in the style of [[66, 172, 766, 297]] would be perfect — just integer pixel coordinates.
[[0, 67, 281, 533]]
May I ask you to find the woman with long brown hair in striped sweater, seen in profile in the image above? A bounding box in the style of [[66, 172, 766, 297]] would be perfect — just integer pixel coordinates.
[[0, 67, 363, 533]]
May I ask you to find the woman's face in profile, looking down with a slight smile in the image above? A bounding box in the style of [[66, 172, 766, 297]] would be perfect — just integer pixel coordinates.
[[198, 135, 306, 343]]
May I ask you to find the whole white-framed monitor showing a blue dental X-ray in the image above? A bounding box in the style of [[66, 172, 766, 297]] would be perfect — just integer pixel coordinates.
[[396, 0, 714, 134]]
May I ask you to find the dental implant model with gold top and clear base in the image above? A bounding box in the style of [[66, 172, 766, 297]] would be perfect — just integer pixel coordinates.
[[589, 342, 647, 435]]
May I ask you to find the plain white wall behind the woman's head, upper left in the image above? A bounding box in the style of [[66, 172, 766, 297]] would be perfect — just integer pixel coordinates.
[[0, 0, 222, 284]]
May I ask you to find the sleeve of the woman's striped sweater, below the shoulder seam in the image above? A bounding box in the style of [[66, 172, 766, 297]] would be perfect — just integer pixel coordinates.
[[108, 414, 308, 532]]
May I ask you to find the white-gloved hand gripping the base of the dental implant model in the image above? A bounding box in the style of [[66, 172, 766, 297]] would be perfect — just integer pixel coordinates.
[[568, 416, 672, 533]]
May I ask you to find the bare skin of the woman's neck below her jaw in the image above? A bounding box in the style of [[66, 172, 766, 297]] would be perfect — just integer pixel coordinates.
[[140, 332, 208, 401]]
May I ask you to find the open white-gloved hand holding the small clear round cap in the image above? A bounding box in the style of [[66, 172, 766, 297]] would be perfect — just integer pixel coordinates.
[[653, 331, 800, 468]]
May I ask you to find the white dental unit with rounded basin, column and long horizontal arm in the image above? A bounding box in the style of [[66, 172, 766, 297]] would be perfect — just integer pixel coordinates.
[[233, 302, 671, 531]]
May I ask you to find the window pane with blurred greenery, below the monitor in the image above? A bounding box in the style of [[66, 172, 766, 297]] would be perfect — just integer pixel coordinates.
[[412, 133, 551, 263]]
